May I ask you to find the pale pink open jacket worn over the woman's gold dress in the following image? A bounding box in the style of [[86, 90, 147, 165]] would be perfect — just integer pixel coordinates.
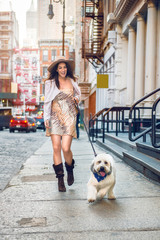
[[44, 79, 81, 121]]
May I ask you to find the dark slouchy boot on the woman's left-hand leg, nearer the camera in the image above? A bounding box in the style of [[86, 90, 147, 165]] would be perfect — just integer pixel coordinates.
[[53, 163, 66, 192]]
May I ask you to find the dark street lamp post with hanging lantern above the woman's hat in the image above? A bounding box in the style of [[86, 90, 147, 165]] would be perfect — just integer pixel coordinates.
[[47, 0, 66, 56]]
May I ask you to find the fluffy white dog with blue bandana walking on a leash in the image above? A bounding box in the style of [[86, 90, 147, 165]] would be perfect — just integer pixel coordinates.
[[87, 153, 116, 202]]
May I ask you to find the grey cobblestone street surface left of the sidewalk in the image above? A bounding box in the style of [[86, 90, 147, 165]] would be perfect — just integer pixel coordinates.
[[0, 129, 46, 192]]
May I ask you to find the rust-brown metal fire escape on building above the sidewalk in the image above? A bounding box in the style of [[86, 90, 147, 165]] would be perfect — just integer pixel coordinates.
[[82, 0, 104, 67]]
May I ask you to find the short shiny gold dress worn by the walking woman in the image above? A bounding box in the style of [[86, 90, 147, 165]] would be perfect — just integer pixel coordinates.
[[46, 89, 77, 138]]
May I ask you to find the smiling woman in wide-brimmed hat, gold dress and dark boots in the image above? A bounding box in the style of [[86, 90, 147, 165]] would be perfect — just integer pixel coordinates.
[[44, 57, 81, 192]]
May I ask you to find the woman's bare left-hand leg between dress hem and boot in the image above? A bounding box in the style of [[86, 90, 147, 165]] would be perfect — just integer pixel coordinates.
[[51, 134, 62, 165]]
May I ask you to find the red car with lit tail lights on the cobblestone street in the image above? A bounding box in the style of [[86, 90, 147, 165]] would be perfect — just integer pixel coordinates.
[[9, 116, 30, 133]]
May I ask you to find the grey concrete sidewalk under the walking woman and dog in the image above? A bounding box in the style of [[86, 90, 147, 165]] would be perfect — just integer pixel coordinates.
[[0, 132, 160, 240]]
